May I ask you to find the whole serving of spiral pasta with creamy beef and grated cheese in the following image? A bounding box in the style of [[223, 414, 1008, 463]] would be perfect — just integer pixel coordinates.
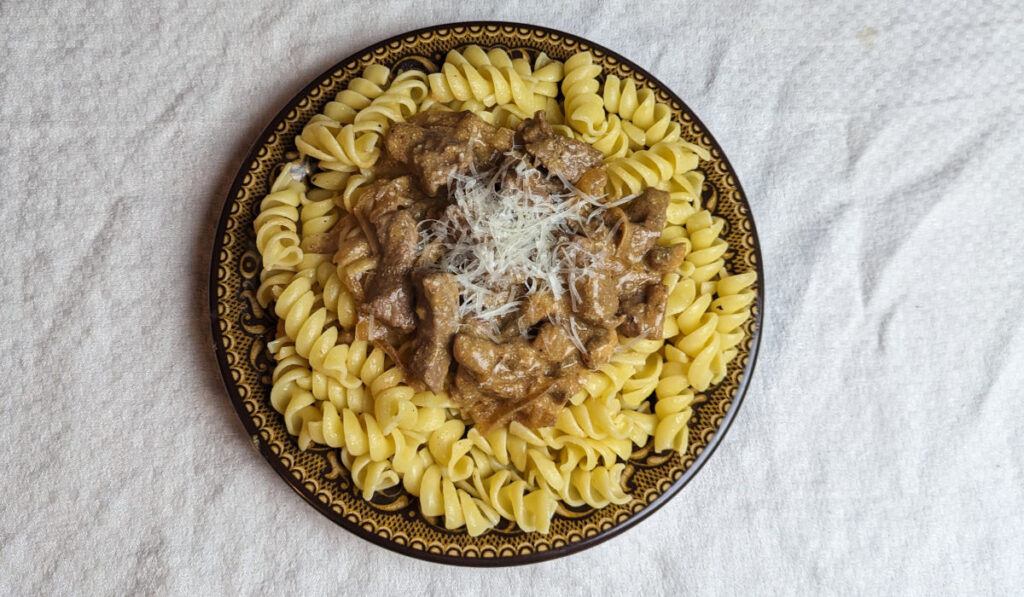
[[255, 46, 755, 536]]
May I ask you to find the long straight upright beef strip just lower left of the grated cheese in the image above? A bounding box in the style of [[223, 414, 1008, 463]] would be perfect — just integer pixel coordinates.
[[409, 270, 459, 393]]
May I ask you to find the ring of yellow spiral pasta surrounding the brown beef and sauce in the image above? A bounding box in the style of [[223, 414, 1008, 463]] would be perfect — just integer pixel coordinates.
[[254, 45, 756, 536]]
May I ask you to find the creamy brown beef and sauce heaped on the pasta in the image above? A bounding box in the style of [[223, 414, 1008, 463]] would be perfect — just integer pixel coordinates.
[[336, 112, 685, 431]]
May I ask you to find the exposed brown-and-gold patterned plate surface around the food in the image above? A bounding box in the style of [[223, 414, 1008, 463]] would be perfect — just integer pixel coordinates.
[[210, 23, 764, 566]]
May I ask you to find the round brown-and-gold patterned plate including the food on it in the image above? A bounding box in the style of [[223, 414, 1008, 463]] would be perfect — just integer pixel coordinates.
[[210, 23, 764, 566]]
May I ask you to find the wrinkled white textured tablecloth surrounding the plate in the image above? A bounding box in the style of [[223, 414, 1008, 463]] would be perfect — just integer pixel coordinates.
[[0, 0, 1024, 595]]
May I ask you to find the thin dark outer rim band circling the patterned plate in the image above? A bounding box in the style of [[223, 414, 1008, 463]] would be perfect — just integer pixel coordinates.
[[209, 20, 764, 567]]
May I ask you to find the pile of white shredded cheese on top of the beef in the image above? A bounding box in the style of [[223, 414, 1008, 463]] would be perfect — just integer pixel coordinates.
[[420, 154, 609, 322]]
